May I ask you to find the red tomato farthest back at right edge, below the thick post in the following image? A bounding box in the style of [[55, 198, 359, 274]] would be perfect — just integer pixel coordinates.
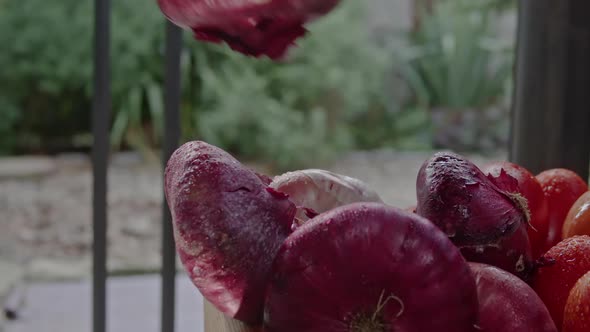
[[537, 168, 588, 253]]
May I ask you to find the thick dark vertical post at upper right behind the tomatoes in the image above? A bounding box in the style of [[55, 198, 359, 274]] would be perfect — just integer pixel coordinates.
[[511, 0, 590, 179]]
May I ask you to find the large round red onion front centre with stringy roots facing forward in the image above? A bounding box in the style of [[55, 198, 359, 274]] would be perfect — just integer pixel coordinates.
[[264, 203, 477, 332]]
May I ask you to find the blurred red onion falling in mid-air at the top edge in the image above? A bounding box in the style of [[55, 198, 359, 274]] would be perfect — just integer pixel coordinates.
[[158, 0, 340, 59]]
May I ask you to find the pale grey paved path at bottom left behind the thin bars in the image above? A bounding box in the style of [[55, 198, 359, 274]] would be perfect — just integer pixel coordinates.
[[4, 275, 203, 332]]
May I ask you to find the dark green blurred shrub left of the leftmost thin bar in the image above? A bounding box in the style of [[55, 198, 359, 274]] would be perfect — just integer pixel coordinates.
[[0, 0, 91, 153]]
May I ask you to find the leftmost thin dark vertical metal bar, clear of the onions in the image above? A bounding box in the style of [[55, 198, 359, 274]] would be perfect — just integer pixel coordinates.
[[92, 0, 111, 332]]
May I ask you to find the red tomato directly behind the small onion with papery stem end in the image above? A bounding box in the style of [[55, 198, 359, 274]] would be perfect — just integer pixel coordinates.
[[482, 161, 548, 259]]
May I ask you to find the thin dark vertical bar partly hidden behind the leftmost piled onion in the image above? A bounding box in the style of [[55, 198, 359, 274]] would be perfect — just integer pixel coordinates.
[[161, 22, 182, 332]]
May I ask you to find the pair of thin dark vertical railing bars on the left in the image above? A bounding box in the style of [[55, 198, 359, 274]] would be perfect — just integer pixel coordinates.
[[92, 0, 182, 332]]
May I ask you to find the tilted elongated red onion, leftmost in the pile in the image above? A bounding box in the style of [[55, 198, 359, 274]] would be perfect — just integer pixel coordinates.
[[165, 142, 296, 323]]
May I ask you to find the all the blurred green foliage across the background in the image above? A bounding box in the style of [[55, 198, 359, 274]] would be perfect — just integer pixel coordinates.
[[0, 0, 520, 165]]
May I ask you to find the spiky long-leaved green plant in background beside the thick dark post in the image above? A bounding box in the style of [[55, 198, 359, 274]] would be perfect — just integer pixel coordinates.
[[400, 1, 512, 110]]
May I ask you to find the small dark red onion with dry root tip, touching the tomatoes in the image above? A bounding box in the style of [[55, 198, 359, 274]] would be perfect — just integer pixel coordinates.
[[416, 152, 529, 247]]
